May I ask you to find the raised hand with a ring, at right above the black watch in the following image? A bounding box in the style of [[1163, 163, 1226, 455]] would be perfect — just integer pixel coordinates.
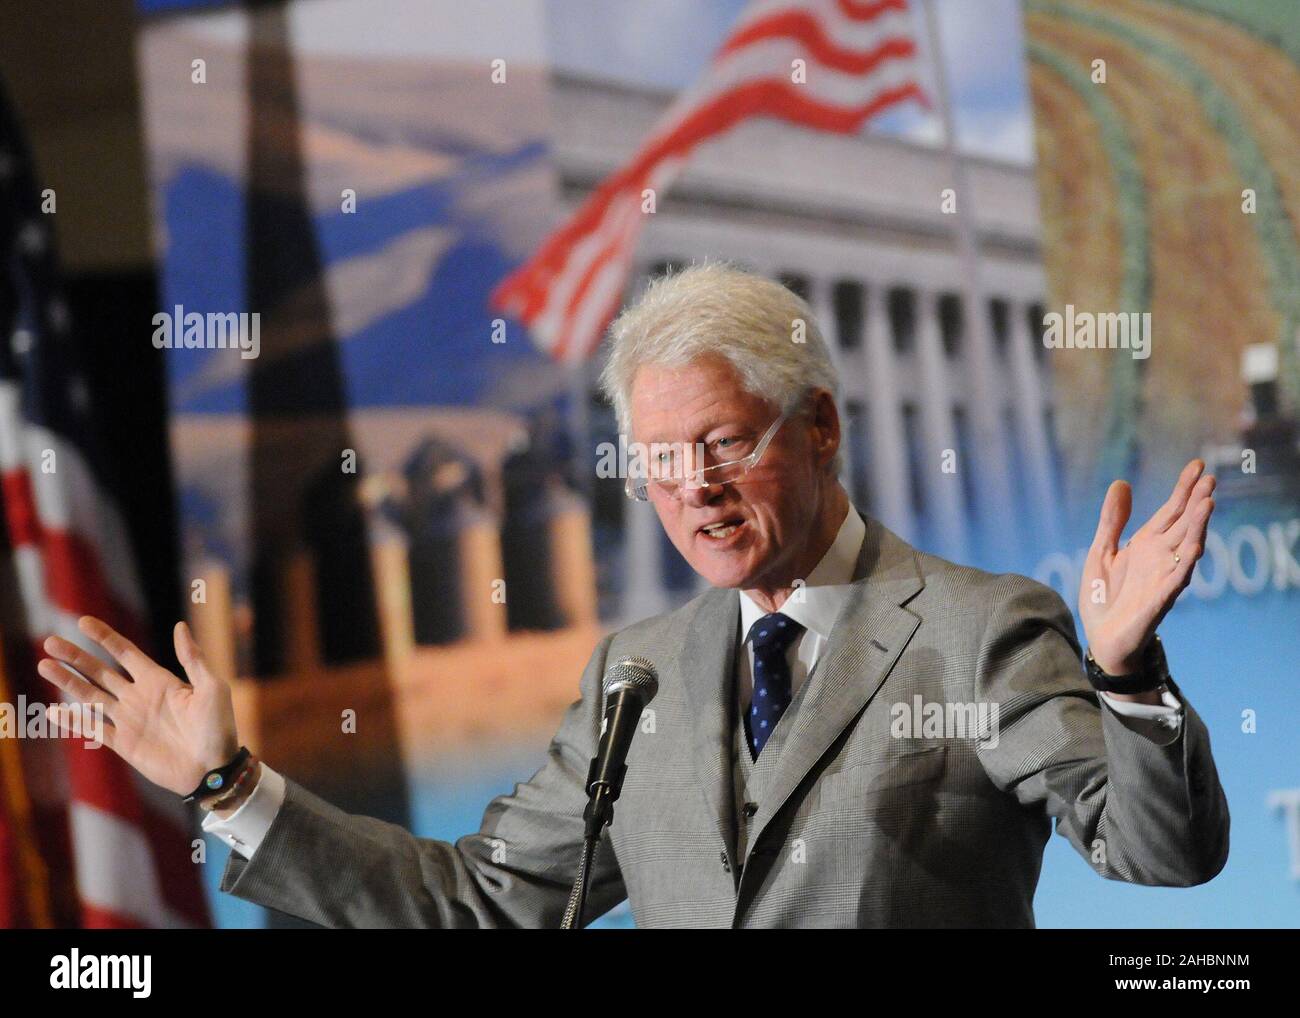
[[1079, 459, 1214, 675]]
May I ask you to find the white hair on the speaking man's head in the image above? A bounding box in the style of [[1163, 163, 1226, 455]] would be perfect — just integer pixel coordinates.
[[601, 261, 842, 475]]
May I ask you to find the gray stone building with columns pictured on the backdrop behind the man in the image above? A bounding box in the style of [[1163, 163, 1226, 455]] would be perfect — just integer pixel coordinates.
[[553, 75, 1061, 623]]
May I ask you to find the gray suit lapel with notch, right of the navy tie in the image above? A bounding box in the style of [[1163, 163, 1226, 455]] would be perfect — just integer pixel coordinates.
[[729, 516, 924, 852]]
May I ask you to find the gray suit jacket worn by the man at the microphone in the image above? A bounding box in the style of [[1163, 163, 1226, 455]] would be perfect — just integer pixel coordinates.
[[221, 519, 1229, 927]]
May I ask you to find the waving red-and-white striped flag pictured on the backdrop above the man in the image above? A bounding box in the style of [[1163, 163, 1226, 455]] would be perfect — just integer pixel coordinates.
[[491, 0, 928, 360]]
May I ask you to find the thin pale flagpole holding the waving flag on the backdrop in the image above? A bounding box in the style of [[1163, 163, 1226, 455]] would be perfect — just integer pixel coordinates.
[[919, 0, 1024, 562]]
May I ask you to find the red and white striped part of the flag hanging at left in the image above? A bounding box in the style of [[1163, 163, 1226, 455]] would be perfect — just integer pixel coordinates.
[[0, 381, 209, 928]]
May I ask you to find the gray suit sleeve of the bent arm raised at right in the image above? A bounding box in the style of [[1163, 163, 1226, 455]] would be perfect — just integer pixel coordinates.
[[976, 576, 1229, 887]]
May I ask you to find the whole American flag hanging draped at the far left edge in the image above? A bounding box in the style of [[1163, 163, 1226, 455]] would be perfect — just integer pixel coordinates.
[[0, 83, 209, 928]]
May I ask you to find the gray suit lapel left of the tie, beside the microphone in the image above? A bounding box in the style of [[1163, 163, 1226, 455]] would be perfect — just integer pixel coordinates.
[[676, 589, 740, 858]]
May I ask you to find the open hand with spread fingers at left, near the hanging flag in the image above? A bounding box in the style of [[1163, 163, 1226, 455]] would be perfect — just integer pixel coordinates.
[[36, 615, 239, 796]]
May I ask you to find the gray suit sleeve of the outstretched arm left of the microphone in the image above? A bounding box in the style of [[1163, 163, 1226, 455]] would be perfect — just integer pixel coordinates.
[[221, 634, 627, 928]]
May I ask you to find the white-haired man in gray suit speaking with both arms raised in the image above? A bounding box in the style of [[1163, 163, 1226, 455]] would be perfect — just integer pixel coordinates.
[[39, 265, 1229, 927]]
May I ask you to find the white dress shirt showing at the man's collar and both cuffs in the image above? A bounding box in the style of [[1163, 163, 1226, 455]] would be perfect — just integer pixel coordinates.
[[203, 506, 1183, 859]]
